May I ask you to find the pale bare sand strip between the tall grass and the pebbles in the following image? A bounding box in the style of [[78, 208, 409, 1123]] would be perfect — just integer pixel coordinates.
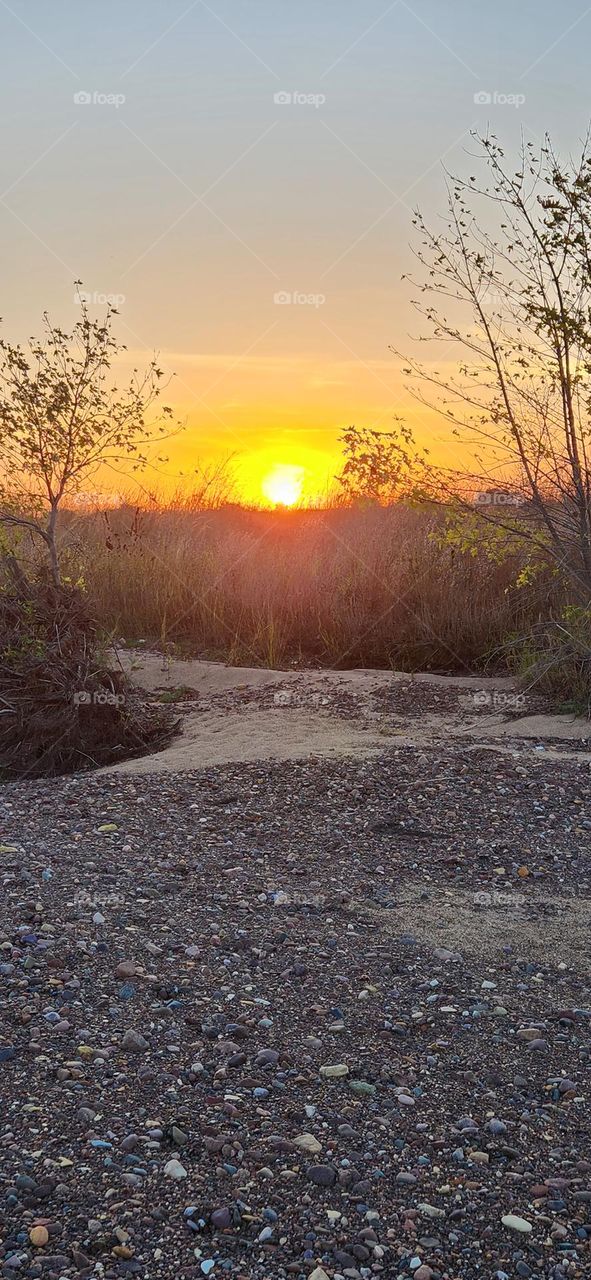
[[111, 653, 591, 774]]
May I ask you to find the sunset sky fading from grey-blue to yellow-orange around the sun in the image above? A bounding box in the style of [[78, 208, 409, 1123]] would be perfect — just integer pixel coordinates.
[[0, 0, 591, 500]]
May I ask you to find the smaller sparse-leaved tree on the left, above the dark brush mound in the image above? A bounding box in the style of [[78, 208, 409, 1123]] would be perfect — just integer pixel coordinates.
[[0, 282, 171, 586]]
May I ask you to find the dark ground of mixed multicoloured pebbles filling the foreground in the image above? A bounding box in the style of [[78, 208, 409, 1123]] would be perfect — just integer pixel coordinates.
[[0, 706, 591, 1280]]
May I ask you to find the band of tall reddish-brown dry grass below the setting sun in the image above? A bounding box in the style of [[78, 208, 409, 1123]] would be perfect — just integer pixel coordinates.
[[54, 504, 548, 672]]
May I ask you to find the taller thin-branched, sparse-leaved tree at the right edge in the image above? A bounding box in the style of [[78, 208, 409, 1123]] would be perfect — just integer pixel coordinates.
[[397, 137, 591, 604]]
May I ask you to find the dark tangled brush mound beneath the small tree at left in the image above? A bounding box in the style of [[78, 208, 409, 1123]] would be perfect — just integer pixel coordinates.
[[0, 557, 170, 778]]
